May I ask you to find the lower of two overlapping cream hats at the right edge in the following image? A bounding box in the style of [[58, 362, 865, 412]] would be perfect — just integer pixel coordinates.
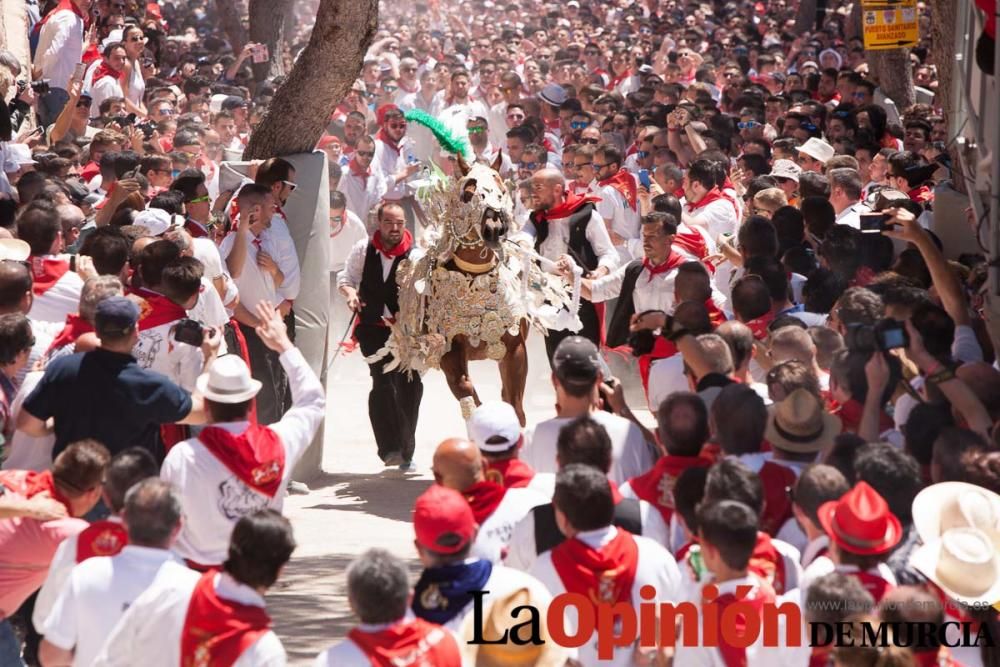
[[910, 528, 1000, 605]]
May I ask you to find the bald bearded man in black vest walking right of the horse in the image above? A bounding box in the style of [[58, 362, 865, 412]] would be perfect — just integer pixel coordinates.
[[523, 168, 618, 364]]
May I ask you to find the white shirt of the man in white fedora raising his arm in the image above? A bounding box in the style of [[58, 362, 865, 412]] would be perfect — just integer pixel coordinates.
[[160, 348, 326, 565]]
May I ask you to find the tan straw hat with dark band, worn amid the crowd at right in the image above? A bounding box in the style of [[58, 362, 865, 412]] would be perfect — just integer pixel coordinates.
[[764, 389, 842, 454]]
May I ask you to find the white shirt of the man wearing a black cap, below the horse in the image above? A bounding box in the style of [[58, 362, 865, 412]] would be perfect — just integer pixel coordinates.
[[520, 410, 656, 485]]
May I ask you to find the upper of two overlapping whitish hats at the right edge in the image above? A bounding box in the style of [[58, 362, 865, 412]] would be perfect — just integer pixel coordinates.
[[913, 482, 1000, 546]]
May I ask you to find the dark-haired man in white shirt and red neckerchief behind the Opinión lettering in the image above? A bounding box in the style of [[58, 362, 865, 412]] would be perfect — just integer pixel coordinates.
[[531, 464, 683, 667]]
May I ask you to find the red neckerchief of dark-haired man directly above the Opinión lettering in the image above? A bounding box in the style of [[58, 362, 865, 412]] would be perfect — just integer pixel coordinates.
[[550, 528, 639, 606]]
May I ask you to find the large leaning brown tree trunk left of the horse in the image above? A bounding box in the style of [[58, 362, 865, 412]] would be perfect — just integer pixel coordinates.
[[243, 0, 378, 160]]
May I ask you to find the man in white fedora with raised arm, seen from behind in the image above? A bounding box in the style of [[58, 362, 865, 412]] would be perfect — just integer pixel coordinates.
[[160, 302, 326, 570]]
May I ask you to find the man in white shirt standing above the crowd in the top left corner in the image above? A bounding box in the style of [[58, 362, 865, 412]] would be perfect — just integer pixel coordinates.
[[32, 0, 92, 127]]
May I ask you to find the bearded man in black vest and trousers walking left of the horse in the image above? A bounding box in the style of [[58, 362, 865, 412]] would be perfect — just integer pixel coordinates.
[[337, 202, 424, 470]]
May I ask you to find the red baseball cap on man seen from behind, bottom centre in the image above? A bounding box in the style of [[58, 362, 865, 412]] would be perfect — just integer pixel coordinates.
[[413, 484, 477, 554]]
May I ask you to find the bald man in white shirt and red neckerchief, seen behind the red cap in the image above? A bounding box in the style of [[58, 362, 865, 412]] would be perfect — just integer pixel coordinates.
[[431, 438, 549, 563]]
